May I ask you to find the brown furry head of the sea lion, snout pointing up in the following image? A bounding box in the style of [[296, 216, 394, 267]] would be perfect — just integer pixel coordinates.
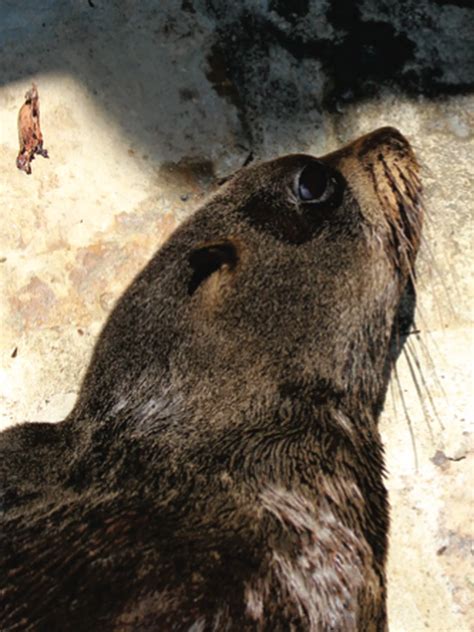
[[72, 127, 422, 436]]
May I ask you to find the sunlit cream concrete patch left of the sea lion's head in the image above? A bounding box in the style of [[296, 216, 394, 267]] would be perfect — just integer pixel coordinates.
[[0, 73, 196, 423]]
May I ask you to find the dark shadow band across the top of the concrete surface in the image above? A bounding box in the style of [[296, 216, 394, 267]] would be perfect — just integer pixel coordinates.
[[0, 0, 474, 165]]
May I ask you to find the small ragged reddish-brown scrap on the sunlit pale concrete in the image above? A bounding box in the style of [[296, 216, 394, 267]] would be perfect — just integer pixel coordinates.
[[16, 84, 49, 175]]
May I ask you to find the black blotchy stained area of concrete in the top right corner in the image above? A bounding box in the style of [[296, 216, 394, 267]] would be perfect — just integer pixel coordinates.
[[203, 0, 474, 146]]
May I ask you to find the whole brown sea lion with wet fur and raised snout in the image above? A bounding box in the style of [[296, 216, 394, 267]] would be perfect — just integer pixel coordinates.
[[0, 128, 423, 632]]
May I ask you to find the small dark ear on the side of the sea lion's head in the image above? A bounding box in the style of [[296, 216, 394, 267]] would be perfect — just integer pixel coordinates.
[[188, 239, 239, 295]]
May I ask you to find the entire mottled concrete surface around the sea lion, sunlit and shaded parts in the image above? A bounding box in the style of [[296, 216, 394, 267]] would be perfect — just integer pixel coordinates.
[[0, 0, 474, 632]]
